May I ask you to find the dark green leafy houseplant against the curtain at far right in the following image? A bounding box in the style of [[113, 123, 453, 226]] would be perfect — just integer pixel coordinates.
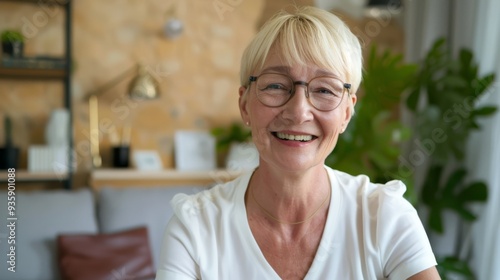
[[406, 38, 497, 279]]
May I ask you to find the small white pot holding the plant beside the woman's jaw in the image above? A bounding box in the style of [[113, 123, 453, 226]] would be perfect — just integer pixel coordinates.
[[226, 142, 259, 171]]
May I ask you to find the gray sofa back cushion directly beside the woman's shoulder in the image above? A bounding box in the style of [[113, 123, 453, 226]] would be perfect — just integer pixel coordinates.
[[98, 186, 205, 268]]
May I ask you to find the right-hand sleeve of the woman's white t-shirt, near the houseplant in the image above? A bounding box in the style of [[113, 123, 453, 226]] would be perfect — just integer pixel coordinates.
[[377, 181, 436, 279]]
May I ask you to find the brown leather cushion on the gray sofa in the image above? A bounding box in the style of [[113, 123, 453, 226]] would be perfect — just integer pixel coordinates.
[[57, 227, 155, 280]]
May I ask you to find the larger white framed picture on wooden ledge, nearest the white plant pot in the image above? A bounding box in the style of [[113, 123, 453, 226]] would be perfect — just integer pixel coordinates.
[[174, 130, 217, 171]]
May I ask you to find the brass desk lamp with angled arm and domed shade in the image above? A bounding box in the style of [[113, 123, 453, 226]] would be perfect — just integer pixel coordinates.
[[88, 65, 160, 168]]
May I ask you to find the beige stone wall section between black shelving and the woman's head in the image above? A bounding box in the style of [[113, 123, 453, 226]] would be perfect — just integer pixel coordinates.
[[74, 0, 268, 173]]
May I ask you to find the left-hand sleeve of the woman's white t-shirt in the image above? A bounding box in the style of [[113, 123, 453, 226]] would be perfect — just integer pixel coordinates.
[[156, 196, 199, 280]]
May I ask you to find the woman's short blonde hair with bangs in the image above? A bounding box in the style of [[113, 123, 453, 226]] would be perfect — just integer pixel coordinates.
[[240, 7, 363, 94]]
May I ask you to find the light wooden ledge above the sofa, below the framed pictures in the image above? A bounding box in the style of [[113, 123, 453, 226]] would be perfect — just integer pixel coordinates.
[[89, 169, 241, 190]]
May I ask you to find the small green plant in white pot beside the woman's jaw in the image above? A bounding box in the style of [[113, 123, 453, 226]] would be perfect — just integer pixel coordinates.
[[211, 122, 259, 170]]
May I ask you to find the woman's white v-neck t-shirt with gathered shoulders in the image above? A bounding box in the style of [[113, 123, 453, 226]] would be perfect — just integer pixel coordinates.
[[156, 167, 436, 280]]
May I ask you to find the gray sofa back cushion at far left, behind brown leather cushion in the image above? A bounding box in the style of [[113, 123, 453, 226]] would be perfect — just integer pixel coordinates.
[[0, 190, 97, 280]]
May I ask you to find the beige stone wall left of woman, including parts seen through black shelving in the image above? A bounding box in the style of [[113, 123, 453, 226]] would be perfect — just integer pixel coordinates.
[[0, 0, 264, 188]]
